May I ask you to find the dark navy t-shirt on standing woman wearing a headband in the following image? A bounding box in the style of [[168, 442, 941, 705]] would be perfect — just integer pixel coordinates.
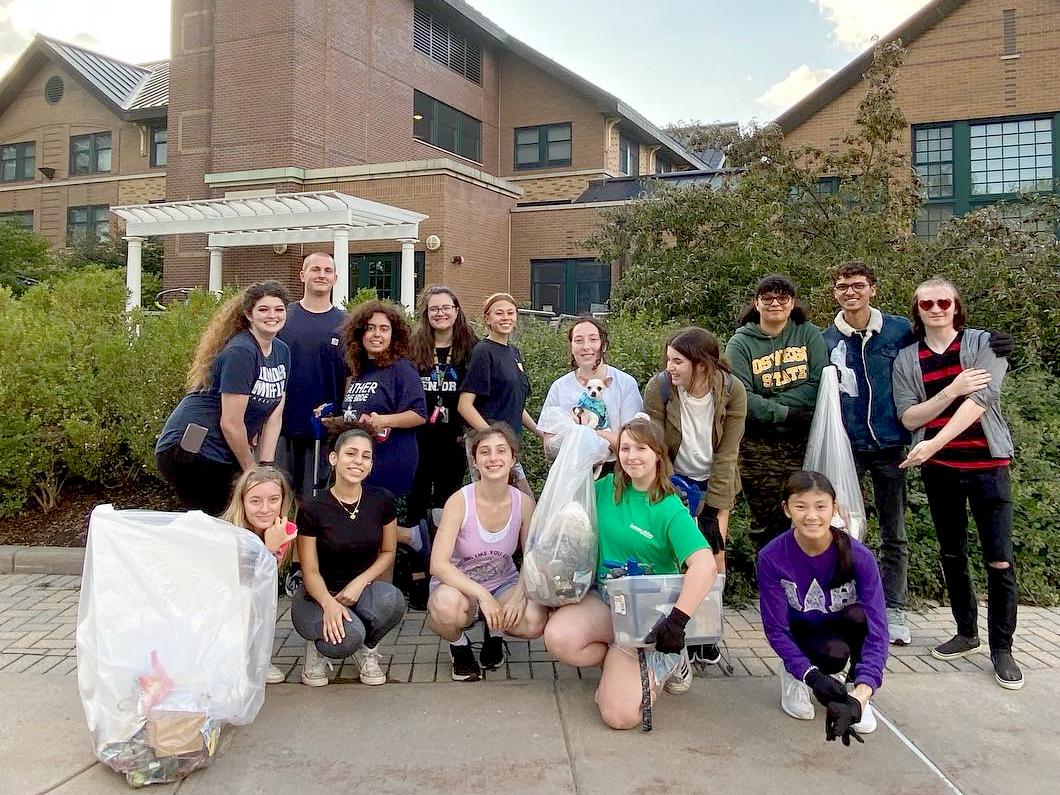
[[460, 339, 530, 436]]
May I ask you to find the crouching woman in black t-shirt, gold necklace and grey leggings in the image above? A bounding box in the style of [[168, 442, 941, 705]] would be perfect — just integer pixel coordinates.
[[290, 429, 405, 687]]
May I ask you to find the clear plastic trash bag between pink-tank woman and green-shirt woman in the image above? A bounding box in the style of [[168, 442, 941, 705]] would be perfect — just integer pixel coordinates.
[[522, 408, 608, 607]]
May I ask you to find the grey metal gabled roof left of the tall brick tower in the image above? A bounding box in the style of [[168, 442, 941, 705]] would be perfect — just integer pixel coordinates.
[[0, 34, 170, 121]]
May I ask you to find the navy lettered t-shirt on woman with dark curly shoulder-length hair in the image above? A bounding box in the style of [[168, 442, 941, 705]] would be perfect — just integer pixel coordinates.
[[342, 359, 427, 497]]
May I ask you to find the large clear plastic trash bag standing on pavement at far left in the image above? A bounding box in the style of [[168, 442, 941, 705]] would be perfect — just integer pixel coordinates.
[[77, 505, 277, 787]]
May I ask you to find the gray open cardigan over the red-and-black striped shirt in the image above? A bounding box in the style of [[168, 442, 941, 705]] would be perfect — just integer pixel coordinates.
[[894, 329, 1014, 458]]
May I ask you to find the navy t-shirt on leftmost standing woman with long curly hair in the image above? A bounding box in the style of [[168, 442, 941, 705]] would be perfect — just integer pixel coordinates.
[[155, 331, 290, 463]]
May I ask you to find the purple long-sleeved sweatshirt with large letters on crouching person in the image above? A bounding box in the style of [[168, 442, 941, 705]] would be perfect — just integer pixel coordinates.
[[758, 530, 889, 690]]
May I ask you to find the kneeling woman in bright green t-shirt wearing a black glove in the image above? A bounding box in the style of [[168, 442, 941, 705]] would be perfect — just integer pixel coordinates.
[[545, 419, 718, 729]]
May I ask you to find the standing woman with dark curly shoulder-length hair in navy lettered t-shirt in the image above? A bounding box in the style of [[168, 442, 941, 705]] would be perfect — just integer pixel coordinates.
[[340, 301, 427, 497]]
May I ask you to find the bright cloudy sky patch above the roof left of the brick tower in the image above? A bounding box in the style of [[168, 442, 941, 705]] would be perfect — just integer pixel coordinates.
[[0, 0, 170, 74]]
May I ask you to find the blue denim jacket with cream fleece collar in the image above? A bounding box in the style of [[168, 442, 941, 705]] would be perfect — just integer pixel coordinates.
[[824, 307, 914, 451]]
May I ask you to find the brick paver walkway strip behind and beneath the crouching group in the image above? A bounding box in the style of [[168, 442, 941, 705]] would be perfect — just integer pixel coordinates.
[[0, 575, 1060, 682]]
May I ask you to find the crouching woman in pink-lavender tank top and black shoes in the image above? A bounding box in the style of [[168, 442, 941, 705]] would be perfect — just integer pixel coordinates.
[[427, 423, 548, 682]]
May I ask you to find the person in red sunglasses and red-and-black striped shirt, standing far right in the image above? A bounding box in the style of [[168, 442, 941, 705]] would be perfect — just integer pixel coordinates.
[[894, 279, 1023, 690]]
